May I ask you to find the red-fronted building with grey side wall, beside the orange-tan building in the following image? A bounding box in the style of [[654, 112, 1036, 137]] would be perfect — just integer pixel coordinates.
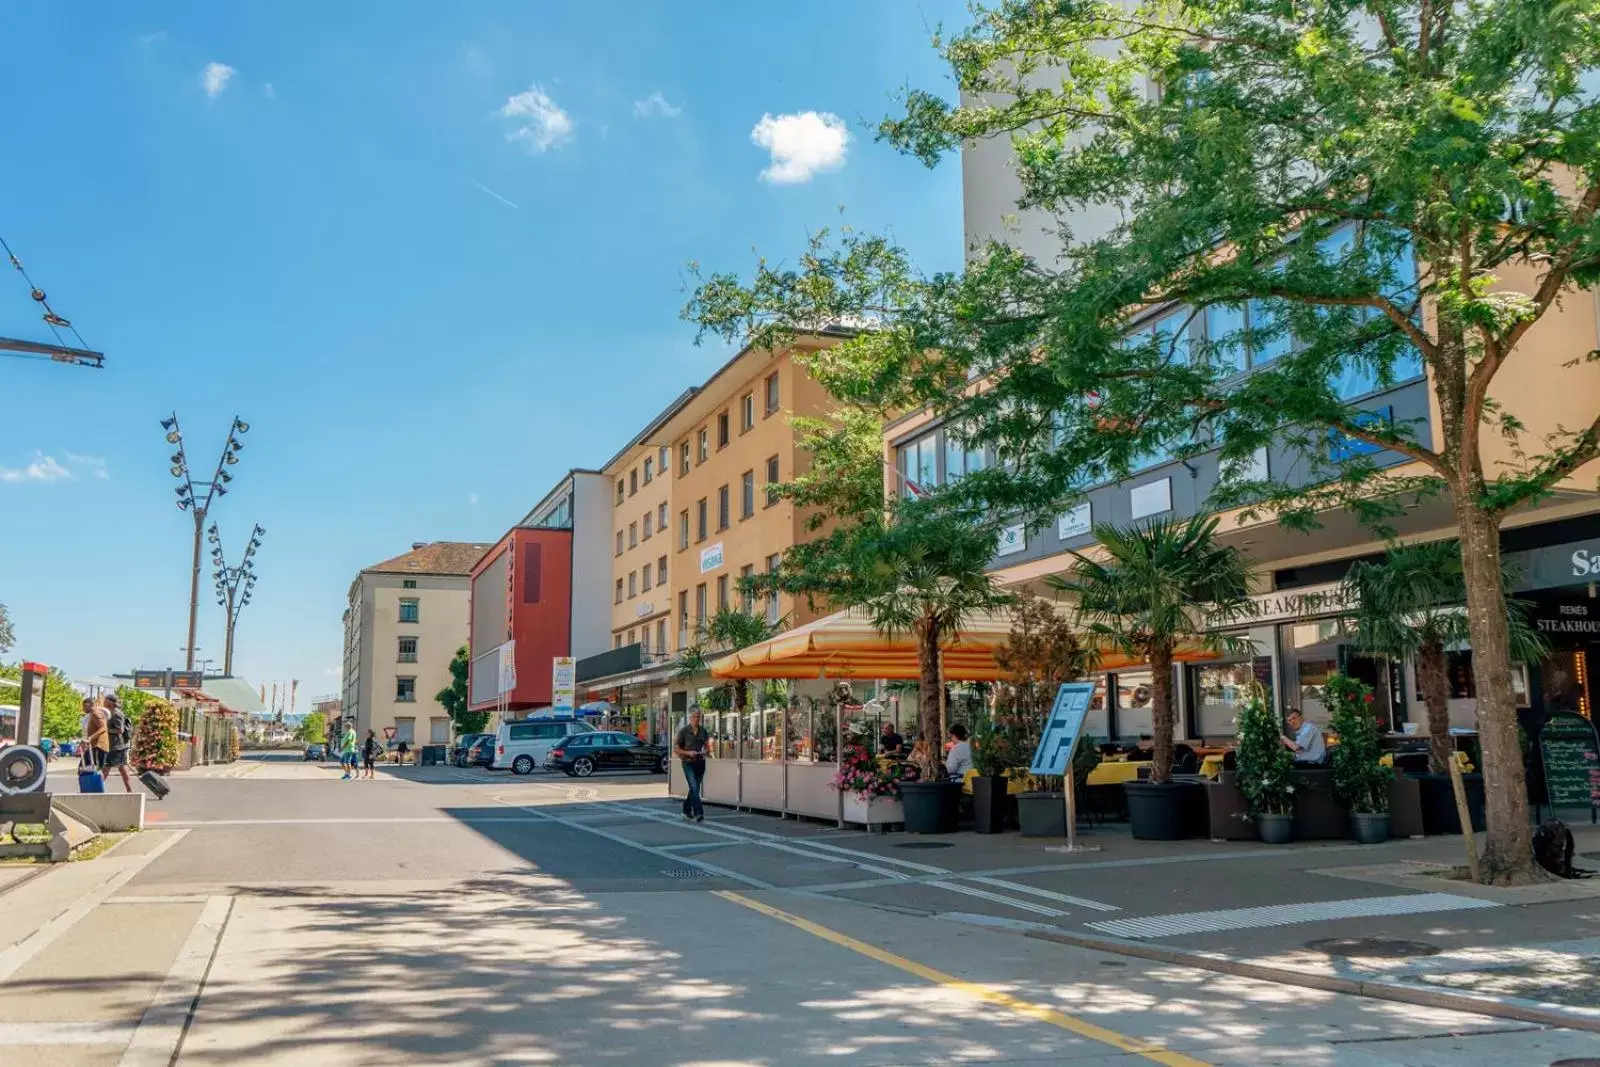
[[469, 470, 611, 712]]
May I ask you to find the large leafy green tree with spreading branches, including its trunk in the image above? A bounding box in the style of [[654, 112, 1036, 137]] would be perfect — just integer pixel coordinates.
[[686, 0, 1600, 881]]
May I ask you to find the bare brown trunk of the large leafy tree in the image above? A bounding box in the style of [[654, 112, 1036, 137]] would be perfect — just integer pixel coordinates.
[[1454, 502, 1539, 885]]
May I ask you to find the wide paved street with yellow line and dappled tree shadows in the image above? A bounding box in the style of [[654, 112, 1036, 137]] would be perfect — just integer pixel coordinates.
[[0, 757, 1600, 1067]]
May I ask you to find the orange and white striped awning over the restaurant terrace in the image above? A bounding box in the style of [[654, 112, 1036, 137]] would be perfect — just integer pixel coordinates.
[[710, 608, 1213, 681]]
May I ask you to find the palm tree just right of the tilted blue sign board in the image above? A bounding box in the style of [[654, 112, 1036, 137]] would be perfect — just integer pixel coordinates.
[[1050, 517, 1253, 782]]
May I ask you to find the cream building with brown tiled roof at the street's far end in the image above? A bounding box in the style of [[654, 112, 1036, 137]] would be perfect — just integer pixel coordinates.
[[339, 541, 490, 745]]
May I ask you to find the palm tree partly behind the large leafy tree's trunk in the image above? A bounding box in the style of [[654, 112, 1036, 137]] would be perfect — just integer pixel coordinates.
[[1346, 541, 1549, 774]]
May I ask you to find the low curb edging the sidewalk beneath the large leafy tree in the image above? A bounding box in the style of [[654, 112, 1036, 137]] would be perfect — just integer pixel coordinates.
[[1024, 929, 1600, 1033]]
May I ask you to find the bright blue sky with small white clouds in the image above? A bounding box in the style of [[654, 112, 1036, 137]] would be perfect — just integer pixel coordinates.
[[0, 0, 963, 709]]
